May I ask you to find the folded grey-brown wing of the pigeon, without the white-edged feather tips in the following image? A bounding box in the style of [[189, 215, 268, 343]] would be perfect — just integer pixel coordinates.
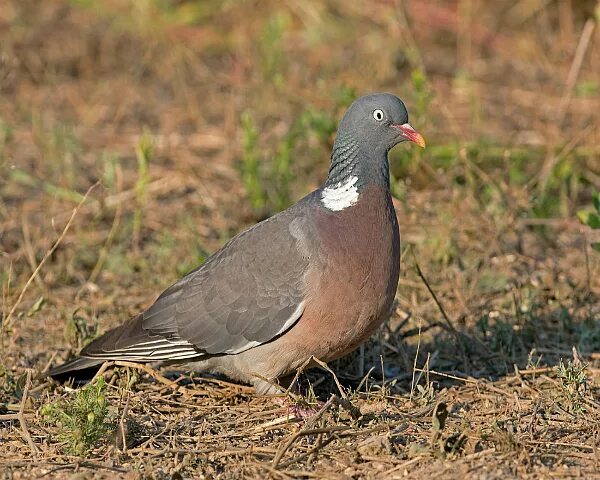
[[142, 215, 309, 354]]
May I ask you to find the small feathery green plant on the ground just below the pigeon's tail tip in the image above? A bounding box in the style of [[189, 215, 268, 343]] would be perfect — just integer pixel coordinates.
[[40, 377, 113, 455]]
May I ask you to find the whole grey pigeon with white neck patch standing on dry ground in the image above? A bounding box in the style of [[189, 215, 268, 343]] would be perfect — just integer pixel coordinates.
[[46, 93, 425, 394]]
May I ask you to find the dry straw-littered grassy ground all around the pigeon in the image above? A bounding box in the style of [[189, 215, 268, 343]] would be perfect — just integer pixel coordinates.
[[0, 0, 600, 479]]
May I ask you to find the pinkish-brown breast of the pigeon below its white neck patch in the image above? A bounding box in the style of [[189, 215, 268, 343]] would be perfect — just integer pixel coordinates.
[[290, 187, 400, 360]]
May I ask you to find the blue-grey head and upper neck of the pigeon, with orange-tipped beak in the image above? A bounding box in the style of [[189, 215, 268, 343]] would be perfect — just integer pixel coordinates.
[[324, 93, 425, 190]]
